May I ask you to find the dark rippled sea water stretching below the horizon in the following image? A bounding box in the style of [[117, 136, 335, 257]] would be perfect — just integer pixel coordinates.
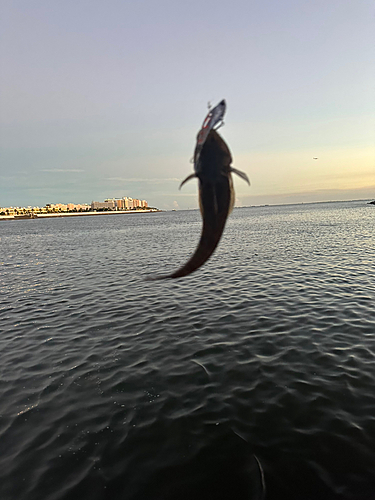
[[0, 202, 375, 500]]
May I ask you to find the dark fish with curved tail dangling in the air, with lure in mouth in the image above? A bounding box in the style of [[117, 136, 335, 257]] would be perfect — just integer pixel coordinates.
[[147, 99, 250, 280]]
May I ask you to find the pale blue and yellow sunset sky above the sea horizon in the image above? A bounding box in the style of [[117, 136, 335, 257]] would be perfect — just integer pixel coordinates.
[[0, 0, 375, 209]]
